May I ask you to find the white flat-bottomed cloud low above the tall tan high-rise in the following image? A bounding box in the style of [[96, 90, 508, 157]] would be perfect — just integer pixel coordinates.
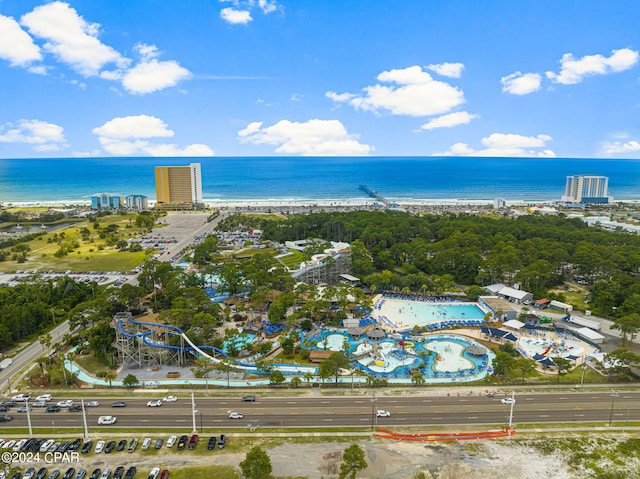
[[91, 115, 214, 156]]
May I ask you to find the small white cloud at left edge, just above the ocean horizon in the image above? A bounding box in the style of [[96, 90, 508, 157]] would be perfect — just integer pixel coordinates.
[[0, 120, 67, 151]]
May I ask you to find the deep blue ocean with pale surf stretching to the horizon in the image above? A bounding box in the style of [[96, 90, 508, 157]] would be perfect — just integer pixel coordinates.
[[0, 157, 640, 203]]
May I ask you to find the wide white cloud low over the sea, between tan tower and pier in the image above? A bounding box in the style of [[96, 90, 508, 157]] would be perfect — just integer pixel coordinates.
[[238, 119, 374, 156]]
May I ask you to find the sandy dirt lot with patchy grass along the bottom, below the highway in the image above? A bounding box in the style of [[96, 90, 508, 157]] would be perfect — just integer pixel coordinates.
[[8, 438, 585, 479]]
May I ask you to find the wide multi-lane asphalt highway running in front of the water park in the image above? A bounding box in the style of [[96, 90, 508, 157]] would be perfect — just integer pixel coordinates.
[[0, 391, 640, 432]]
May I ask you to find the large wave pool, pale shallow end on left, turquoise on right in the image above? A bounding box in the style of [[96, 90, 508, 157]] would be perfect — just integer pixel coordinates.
[[374, 298, 486, 329]]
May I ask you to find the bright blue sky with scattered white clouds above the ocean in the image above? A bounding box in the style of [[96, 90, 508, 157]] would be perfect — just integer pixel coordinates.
[[0, 0, 640, 158]]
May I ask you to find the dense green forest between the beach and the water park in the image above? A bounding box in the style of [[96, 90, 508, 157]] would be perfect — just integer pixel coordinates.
[[220, 211, 640, 318]]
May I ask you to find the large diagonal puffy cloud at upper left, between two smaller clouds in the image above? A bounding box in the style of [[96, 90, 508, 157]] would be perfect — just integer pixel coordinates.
[[20, 1, 128, 77]]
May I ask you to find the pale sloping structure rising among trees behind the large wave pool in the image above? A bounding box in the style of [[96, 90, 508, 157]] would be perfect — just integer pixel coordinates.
[[289, 241, 351, 284]]
